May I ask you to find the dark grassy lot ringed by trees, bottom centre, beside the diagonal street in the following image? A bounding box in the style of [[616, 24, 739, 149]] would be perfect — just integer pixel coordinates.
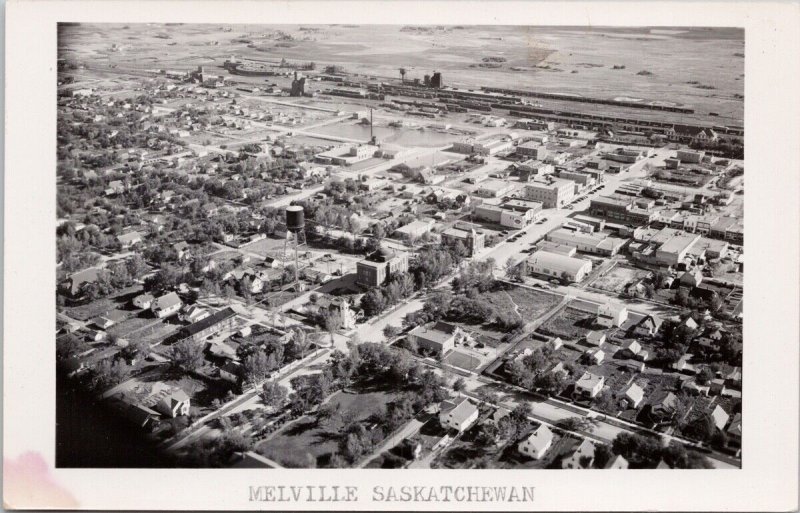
[[257, 392, 395, 468]]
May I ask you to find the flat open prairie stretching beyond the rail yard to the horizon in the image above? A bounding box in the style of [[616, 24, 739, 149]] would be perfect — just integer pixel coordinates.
[[59, 24, 744, 122]]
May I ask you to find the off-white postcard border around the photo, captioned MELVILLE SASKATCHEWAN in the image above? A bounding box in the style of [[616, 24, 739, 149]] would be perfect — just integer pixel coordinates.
[[3, 1, 800, 511]]
